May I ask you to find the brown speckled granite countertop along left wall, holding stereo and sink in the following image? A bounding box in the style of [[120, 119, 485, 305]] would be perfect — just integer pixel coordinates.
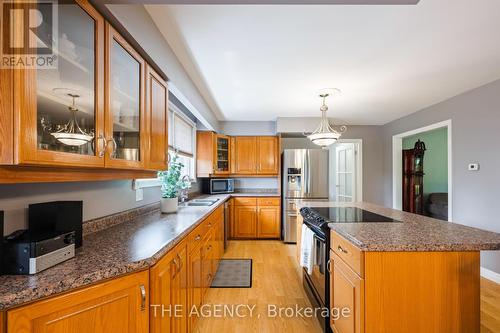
[[0, 192, 279, 311]]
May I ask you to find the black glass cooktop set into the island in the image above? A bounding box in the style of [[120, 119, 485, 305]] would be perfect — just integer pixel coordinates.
[[311, 207, 401, 223]]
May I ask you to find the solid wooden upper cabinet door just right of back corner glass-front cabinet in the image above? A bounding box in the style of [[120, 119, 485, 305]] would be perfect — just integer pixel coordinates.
[[234, 136, 257, 175]]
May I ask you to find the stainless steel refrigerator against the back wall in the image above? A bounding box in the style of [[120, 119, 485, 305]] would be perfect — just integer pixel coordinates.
[[282, 149, 328, 243]]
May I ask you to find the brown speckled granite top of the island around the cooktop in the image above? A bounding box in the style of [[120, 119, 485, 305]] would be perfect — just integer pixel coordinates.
[[298, 200, 500, 251]]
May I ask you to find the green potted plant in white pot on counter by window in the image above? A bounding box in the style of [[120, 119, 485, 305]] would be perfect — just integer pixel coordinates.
[[158, 153, 189, 213]]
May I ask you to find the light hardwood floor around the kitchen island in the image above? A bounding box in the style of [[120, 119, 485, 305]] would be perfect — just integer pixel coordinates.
[[194, 241, 500, 333]]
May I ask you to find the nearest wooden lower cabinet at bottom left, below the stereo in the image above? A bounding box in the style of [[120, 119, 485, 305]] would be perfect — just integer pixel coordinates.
[[7, 271, 149, 333]]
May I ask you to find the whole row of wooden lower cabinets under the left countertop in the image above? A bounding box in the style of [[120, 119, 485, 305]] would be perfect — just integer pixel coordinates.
[[0, 207, 224, 333]]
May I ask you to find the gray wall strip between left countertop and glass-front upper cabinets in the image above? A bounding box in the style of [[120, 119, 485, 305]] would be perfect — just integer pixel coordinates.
[[0, 180, 160, 234]]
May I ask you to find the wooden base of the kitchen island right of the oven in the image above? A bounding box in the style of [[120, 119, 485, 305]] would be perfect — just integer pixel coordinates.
[[329, 231, 480, 333]]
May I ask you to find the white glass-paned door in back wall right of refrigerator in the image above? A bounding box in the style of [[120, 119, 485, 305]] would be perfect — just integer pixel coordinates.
[[329, 140, 363, 202]]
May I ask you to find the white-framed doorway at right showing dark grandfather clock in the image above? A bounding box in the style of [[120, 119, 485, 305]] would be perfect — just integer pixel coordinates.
[[392, 120, 453, 221]]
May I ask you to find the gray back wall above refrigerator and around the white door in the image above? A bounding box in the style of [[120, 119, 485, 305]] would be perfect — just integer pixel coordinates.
[[278, 124, 384, 205]]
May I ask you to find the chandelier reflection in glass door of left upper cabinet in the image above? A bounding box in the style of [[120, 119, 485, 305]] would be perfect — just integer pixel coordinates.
[[41, 94, 94, 147]]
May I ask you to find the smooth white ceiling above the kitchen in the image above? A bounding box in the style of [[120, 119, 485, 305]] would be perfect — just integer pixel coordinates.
[[146, 0, 500, 124]]
